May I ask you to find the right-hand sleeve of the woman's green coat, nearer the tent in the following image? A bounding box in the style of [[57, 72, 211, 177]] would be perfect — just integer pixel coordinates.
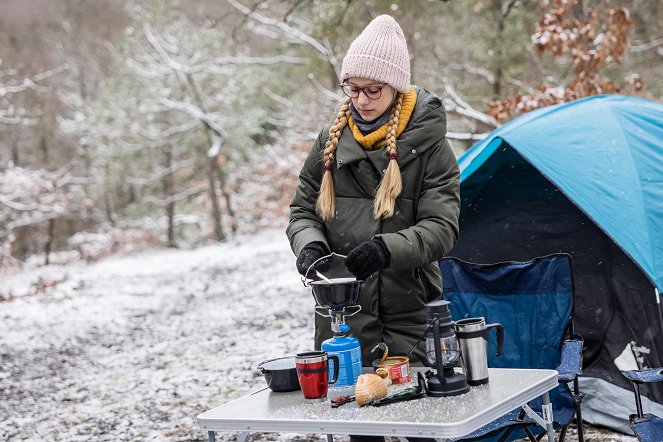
[[376, 139, 460, 269]]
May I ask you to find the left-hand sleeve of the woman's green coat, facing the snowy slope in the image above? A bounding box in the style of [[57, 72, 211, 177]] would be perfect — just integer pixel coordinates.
[[286, 129, 329, 255]]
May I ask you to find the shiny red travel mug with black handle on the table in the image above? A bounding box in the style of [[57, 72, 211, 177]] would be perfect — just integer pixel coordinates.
[[295, 351, 339, 402]]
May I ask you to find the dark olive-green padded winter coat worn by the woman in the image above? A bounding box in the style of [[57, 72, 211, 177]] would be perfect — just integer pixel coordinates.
[[286, 88, 460, 366]]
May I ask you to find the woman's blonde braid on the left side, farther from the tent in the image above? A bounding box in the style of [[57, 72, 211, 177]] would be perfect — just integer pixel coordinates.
[[315, 98, 350, 221]]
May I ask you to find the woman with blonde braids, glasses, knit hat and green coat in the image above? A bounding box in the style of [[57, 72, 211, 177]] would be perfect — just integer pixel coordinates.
[[287, 15, 460, 378]]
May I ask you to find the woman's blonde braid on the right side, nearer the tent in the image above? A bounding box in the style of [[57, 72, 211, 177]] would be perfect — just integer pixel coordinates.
[[373, 93, 403, 219]]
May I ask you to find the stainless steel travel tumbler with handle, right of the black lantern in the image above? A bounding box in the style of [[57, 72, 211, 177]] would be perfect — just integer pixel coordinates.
[[455, 317, 504, 385]]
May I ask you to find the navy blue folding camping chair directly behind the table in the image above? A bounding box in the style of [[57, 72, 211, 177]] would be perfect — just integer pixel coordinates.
[[440, 253, 584, 442]]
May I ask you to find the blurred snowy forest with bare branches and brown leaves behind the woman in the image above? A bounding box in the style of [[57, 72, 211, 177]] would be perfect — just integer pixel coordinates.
[[0, 0, 663, 272]]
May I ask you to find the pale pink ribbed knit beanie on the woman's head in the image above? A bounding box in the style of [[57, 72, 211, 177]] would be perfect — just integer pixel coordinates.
[[341, 14, 410, 93]]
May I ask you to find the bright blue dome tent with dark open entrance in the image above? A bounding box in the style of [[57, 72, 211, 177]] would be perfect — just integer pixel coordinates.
[[449, 95, 663, 432]]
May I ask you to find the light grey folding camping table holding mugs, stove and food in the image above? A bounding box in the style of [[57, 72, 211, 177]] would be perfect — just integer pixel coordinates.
[[198, 368, 559, 442]]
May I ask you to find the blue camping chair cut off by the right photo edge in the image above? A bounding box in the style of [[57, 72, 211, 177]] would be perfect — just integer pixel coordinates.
[[622, 367, 663, 442]]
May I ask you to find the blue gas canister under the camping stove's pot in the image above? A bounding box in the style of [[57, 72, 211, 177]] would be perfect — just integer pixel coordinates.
[[321, 324, 362, 387]]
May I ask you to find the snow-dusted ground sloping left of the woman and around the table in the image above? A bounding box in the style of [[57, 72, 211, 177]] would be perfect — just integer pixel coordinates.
[[0, 229, 634, 441]]
